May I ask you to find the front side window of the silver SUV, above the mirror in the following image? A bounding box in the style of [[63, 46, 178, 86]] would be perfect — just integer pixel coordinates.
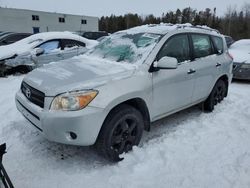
[[157, 34, 190, 63]]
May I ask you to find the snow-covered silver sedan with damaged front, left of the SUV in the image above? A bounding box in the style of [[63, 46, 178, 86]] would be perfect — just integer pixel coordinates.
[[0, 32, 98, 75]]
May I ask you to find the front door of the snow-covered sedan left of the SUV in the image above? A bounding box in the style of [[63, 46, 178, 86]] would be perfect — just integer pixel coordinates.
[[35, 40, 63, 66]]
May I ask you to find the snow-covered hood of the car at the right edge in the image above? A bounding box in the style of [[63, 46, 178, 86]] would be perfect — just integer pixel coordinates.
[[229, 49, 250, 63]]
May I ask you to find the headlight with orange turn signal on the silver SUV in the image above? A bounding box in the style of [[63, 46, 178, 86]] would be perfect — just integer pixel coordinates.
[[50, 90, 98, 111]]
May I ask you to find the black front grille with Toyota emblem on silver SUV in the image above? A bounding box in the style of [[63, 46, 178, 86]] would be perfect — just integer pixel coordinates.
[[21, 82, 45, 108]]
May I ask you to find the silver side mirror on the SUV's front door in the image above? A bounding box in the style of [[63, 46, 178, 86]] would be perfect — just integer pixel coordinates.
[[153, 56, 178, 70]]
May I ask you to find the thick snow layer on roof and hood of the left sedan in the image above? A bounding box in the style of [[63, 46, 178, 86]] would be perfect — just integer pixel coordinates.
[[0, 31, 98, 60]]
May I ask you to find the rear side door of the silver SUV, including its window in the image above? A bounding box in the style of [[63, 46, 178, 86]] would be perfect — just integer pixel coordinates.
[[190, 33, 219, 103]]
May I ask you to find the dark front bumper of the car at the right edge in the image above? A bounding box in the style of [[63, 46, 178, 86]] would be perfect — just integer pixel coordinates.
[[233, 63, 250, 80]]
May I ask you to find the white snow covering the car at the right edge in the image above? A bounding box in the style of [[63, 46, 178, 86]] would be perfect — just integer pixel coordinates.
[[229, 39, 250, 63]]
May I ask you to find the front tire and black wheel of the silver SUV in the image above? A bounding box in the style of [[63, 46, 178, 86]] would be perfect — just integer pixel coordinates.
[[95, 104, 144, 162]]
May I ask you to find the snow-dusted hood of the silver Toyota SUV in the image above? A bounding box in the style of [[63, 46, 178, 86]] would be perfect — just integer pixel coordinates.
[[24, 55, 137, 96]]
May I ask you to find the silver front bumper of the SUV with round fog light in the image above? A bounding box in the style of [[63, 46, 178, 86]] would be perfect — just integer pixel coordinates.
[[16, 90, 107, 146]]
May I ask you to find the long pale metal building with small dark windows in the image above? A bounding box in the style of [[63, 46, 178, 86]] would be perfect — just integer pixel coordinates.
[[0, 7, 98, 33]]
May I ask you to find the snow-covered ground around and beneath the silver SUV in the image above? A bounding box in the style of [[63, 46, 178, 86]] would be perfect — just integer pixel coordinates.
[[0, 76, 250, 188]]
